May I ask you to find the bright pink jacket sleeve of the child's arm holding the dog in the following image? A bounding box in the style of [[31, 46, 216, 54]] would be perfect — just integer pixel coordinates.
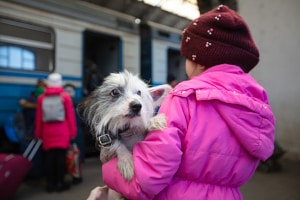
[[102, 94, 186, 199]]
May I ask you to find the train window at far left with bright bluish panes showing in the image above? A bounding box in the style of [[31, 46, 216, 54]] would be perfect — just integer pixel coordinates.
[[0, 17, 54, 72]]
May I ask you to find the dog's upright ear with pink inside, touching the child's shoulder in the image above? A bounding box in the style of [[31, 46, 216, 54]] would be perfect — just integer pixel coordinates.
[[149, 84, 172, 108]]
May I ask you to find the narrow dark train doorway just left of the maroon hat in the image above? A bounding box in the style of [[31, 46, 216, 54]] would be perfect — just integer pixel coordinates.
[[167, 48, 187, 84]]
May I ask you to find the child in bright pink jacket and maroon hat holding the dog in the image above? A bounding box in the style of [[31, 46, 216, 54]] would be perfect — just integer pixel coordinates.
[[90, 5, 275, 200]]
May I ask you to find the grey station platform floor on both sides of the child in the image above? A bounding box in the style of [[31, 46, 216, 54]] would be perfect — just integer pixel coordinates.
[[13, 157, 300, 200]]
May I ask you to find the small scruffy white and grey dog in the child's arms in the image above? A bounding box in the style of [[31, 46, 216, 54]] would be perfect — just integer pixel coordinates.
[[77, 71, 171, 180]]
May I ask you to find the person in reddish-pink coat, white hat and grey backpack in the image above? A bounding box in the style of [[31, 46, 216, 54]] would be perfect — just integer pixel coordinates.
[[35, 73, 77, 192]]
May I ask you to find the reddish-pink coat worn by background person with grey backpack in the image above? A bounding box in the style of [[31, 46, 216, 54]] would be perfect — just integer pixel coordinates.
[[35, 87, 77, 150]]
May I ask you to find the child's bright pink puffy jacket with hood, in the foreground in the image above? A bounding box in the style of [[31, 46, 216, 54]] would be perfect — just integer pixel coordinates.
[[102, 64, 275, 200]]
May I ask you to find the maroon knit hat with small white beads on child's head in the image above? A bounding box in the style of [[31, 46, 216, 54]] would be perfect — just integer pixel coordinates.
[[181, 5, 259, 73]]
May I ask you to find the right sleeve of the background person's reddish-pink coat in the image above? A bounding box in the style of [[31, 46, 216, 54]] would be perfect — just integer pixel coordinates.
[[64, 94, 77, 138]]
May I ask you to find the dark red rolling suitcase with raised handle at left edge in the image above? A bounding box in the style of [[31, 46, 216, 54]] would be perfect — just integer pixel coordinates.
[[0, 140, 42, 200]]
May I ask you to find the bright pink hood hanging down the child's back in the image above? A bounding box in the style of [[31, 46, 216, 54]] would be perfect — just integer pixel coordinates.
[[176, 64, 275, 160]]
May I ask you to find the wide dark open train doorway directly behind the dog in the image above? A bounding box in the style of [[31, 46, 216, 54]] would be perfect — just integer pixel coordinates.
[[83, 30, 123, 154]]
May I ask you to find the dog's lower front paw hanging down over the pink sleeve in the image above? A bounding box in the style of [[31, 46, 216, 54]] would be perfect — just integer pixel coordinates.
[[118, 154, 134, 181]]
